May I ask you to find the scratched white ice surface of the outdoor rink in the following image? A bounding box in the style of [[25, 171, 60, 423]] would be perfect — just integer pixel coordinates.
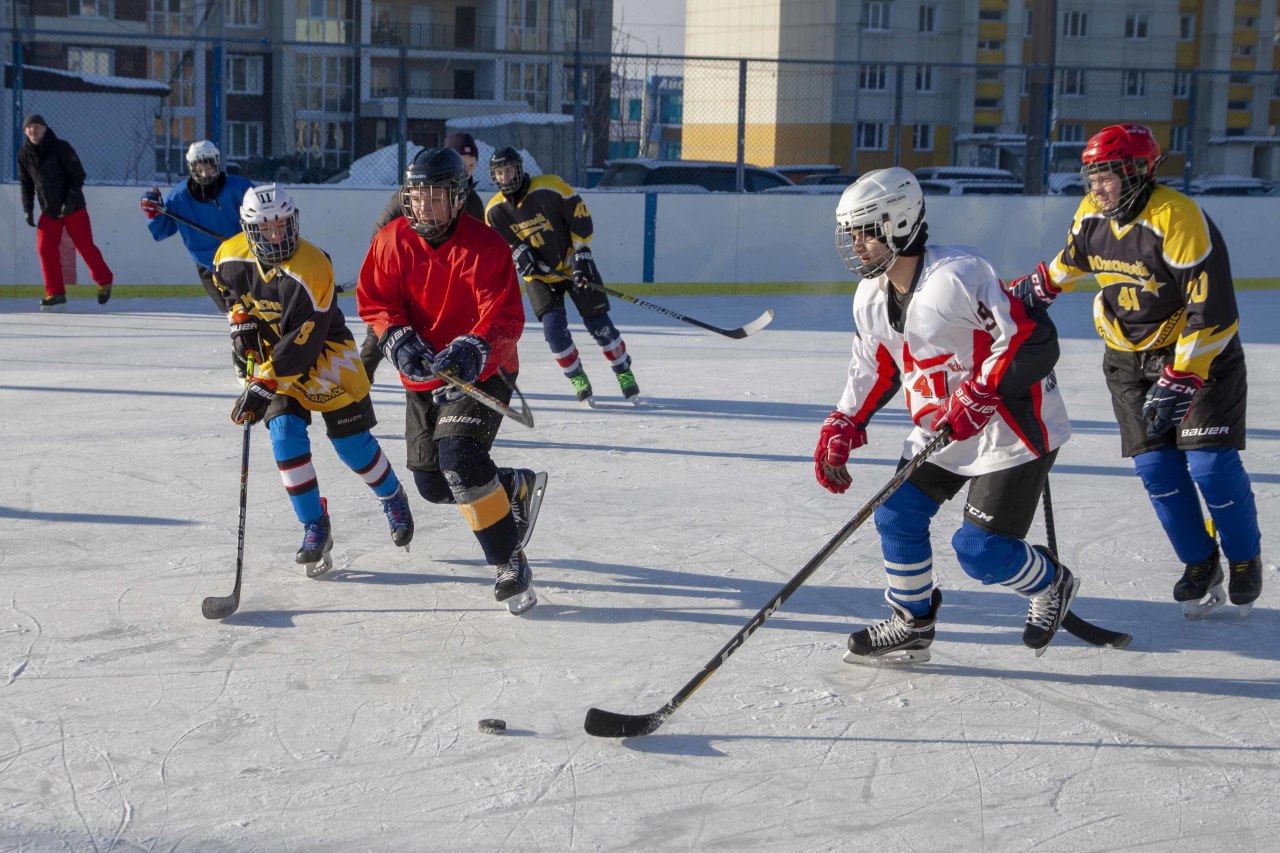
[[0, 292, 1280, 852]]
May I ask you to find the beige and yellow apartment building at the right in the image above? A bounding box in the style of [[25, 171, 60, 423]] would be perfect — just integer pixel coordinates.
[[684, 0, 1280, 178]]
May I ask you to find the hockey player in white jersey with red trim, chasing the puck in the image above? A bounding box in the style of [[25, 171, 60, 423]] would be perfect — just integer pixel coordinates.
[[814, 168, 1079, 662]]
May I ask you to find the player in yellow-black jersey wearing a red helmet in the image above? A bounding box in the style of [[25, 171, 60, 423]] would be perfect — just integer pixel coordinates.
[[1010, 124, 1262, 616]]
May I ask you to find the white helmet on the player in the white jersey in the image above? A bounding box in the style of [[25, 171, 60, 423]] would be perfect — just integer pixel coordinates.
[[836, 167, 924, 278]]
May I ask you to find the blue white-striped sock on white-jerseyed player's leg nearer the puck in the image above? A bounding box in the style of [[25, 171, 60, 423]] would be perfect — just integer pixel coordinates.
[[876, 483, 938, 616]]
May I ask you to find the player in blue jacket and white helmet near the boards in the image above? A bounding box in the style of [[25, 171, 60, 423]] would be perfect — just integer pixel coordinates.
[[141, 140, 253, 312]]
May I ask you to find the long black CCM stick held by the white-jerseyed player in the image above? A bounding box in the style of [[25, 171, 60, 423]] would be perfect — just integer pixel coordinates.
[[584, 427, 951, 738]]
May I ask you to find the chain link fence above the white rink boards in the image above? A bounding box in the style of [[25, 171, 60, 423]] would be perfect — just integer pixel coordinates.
[[0, 20, 1280, 195]]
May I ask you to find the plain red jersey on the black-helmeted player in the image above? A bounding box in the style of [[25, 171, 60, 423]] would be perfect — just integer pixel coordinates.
[[356, 216, 525, 391]]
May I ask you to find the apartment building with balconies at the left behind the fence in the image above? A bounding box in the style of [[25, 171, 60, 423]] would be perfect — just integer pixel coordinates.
[[4, 0, 613, 181]]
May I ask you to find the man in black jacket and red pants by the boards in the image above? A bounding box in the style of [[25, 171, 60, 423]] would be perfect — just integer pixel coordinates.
[[18, 113, 113, 311]]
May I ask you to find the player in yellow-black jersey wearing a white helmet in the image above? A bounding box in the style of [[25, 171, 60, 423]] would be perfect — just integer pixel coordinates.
[[214, 183, 413, 576]]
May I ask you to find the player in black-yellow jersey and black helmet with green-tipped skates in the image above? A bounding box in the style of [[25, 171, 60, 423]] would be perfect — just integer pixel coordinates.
[[485, 147, 640, 405]]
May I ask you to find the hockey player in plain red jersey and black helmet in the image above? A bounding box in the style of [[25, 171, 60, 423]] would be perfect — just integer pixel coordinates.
[[356, 149, 545, 613]]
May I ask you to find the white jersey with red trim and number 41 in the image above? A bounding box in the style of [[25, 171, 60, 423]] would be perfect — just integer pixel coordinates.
[[838, 246, 1071, 476]]
